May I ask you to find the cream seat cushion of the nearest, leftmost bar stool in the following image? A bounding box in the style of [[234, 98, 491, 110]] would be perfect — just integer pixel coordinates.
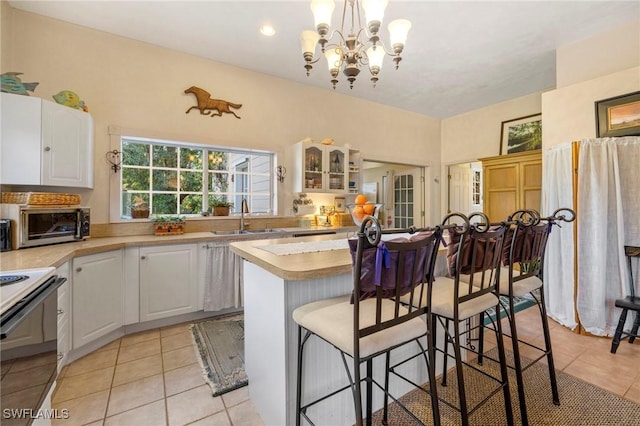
[[293, 296, 427, 358]]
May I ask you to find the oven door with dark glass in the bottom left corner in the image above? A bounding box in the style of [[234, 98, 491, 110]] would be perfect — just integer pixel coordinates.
[[0, 276, 66, 425]]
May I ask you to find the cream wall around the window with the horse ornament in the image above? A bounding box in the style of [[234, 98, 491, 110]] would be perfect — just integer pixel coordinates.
[[2, 8, 440, 223]]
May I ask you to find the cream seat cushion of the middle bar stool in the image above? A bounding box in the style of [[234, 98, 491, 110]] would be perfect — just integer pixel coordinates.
[[400, 277, 498, 320]]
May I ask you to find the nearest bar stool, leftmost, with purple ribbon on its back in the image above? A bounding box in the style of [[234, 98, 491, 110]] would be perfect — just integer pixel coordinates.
[[293, 217, 441, 426]]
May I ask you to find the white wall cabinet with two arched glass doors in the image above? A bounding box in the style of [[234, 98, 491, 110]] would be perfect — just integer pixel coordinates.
[[293, 142, 349, 194]]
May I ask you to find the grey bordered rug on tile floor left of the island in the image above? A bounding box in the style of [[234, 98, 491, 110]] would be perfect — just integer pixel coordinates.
[[189, 314, 249, 396]]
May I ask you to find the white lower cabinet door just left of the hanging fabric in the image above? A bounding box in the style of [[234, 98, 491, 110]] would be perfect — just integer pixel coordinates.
[[140, 244, 198, 321]]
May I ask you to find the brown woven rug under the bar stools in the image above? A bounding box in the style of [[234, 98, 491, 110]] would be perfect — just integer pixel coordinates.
[[373, 349, 640, 426]]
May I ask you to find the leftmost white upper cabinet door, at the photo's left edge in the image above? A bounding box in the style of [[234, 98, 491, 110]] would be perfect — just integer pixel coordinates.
[[0, 93, 42, 185]]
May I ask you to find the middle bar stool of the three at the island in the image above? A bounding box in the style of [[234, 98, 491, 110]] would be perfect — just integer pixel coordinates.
[[402, 213, 513, 426]]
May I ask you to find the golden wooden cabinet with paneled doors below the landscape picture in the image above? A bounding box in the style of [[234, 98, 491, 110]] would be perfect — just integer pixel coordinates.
[[480, 150, 542, 221]]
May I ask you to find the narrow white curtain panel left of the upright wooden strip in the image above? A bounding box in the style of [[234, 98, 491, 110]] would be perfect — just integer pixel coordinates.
[[541, 143, 578, 330]]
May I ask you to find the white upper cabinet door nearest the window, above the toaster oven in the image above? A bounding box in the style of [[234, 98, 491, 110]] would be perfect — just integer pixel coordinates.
[[42, 101, 93, 188]]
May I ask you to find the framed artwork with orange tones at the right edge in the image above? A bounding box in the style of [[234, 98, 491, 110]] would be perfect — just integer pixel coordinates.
[[596, 92, 640, 138]]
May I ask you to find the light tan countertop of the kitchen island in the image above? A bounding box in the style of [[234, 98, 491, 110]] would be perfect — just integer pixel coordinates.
[[230, 233, 352, 281]]
